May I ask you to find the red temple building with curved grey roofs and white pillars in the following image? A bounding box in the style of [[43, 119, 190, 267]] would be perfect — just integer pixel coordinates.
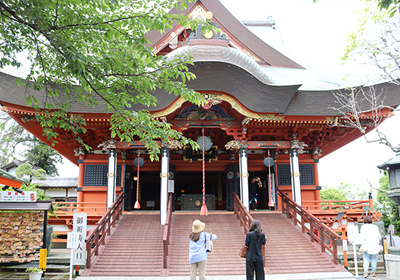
[[0, 0, 400, 230]]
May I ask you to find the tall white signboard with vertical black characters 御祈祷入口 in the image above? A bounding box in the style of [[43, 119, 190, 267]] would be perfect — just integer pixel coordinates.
[[73, 213, 87, 265]]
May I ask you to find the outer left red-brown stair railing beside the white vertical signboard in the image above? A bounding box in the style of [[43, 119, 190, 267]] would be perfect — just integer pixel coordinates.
[[85, 194, 125, 268]]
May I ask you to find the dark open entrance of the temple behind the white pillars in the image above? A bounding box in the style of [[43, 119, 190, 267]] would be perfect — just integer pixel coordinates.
[[124, 164, 276, 211]]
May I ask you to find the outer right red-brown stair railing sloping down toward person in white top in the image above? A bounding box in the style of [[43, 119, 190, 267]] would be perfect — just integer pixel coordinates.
[[278, 190, 340, 264]]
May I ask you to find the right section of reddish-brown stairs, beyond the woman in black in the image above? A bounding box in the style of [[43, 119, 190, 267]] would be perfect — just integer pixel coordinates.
[[255, 212, 346, 274]]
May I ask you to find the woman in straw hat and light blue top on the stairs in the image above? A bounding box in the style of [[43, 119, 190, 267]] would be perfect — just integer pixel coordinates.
[[189, 220, 217, 280]]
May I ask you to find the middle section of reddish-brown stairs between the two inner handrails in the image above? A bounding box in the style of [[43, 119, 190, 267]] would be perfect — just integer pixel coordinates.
[[169, 212, 246, 276]]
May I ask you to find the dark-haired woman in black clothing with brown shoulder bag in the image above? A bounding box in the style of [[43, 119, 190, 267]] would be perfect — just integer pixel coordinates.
[[244, 220, 265, 280]]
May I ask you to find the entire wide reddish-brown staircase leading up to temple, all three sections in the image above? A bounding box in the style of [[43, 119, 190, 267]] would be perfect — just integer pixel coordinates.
[[82, 211, 346, 277]]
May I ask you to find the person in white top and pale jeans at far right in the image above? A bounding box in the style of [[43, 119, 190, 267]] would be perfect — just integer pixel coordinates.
[[361, 215, 382, 278]]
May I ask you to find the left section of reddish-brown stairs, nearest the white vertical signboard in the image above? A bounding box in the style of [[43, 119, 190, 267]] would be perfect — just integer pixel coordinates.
[[82, 212, 164, 276]]
